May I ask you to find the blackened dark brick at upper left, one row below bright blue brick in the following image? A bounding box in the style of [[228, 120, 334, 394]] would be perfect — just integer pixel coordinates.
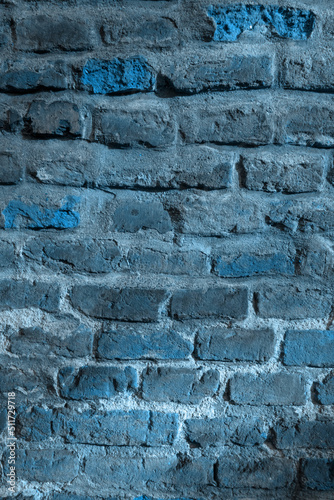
[[26, 101, 91, 139]]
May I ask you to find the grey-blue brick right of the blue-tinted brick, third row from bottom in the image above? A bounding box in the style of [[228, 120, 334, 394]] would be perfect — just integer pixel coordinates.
[[142, 367, 219, 404]]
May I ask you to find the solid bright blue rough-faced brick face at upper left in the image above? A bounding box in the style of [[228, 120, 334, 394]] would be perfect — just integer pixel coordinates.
[[81, 57, 155, 94]]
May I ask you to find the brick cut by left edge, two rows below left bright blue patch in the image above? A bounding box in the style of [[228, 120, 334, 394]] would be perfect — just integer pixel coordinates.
[[0, 280, 60, 312]]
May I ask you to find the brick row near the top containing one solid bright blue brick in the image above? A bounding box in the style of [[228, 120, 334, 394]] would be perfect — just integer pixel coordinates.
[[0, 47, 334, 95]]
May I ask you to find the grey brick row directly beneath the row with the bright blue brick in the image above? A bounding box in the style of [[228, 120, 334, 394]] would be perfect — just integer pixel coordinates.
[[0, 92, 334, 148]]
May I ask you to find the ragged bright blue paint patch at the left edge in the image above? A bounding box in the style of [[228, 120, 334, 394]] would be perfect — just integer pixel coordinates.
[[2, 196, 80, 229]]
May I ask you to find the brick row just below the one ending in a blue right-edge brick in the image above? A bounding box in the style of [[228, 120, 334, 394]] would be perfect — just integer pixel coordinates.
[[0, 360, 334, 408]]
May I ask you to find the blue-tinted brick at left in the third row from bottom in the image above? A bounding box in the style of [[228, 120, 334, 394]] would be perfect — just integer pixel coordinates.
[[58, 366, 137, 400]]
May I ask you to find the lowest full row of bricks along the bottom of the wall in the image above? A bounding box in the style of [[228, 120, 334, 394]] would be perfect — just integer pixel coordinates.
[[1, 448, 333, 490]]
